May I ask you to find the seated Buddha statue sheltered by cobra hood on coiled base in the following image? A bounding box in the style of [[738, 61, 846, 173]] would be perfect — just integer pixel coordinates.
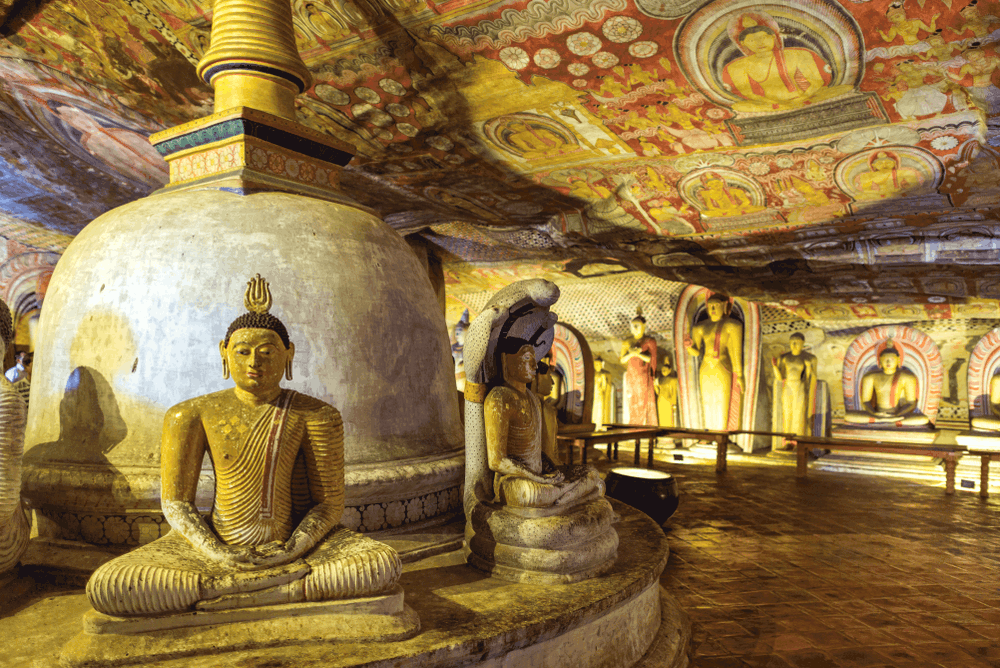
[[465, 279, 618, 583]]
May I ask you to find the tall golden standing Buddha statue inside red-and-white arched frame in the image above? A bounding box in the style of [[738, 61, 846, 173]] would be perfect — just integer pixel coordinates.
[[684, 293, 743, 431]]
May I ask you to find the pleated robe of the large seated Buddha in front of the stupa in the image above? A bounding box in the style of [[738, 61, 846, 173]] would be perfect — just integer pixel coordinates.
[[87, 390, 402, 616]]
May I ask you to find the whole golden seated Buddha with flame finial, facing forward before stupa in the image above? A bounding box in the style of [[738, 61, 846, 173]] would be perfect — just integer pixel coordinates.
[[87, 275, 402, 617]]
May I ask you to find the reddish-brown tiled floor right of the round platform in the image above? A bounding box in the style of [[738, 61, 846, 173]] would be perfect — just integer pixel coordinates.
[[644, 462, 1000, 668]]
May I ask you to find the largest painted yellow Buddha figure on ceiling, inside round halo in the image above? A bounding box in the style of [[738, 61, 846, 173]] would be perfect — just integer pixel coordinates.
[[722, 13, 853, 113]]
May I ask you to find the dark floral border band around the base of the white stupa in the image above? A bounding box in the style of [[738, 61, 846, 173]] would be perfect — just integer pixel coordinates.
[[37, 486, 462, 547]]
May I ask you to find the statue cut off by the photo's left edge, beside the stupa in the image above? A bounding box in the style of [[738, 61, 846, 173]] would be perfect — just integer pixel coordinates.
[[0, 300, 30, 574]]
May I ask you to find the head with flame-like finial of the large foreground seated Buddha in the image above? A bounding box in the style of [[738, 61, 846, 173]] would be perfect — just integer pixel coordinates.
[[219, 274, 295, 395]]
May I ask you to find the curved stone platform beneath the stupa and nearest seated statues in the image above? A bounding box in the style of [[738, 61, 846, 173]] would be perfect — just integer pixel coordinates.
[[0, 501, 690, 668]]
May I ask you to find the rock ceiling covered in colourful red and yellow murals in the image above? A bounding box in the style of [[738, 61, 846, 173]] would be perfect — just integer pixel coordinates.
[[0, 0, 1000, 307]]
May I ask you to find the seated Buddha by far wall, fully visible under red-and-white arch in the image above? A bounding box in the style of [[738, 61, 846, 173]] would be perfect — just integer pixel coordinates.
[[844, 341, 930, 427]]
